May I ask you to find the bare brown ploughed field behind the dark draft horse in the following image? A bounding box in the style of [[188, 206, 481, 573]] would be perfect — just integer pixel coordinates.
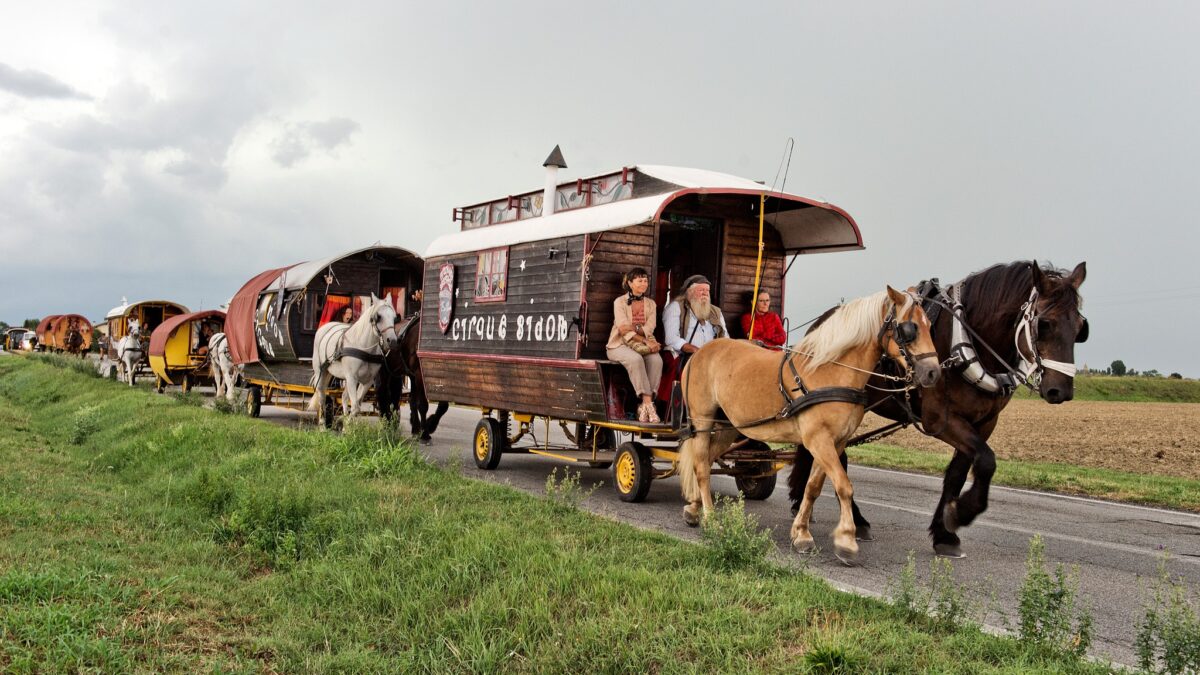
[[863, 400, 1200, 479]]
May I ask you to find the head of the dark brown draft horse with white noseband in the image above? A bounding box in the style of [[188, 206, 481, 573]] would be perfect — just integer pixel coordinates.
[[1016, 261, 1088, 404]]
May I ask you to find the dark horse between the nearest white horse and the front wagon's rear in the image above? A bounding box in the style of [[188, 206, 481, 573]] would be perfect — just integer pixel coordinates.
[[376, 312, 450, 444]]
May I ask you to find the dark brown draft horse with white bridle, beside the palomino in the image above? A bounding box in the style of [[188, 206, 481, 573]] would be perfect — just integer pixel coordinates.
[[788, 261, 1088, 557]]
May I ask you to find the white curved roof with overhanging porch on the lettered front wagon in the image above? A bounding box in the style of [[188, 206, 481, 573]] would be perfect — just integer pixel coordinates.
[[425, 165, 863, 258]]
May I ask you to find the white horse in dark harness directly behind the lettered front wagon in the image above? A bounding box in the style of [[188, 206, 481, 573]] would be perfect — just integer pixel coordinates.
[[308, 293, 397, 423]]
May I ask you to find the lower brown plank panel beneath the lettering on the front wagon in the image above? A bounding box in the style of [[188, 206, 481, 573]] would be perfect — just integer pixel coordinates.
[[421, 353, 606, 422]]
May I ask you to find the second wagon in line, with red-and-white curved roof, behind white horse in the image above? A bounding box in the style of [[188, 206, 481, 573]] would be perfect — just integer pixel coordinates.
[[226, 241, 422, 423]]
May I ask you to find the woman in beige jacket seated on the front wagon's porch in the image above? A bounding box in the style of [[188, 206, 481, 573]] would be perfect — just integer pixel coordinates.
[[605, 267, 662, 424]]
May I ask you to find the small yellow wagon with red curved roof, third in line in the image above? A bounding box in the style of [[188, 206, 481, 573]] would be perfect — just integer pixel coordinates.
[[149, 310, 224, 392]]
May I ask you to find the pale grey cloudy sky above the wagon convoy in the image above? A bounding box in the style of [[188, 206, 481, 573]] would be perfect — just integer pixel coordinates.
[[0, 0, 1200, 377]]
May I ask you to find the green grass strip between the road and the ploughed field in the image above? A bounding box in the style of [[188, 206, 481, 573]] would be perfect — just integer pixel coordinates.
[[847, 443, 1200, 510]]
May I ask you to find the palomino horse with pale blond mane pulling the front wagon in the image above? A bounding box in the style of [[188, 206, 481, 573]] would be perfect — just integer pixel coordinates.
[[679, 287, 941, 565]]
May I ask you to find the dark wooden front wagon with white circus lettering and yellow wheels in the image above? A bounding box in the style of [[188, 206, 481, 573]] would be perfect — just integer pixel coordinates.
[[419, 162, 863, 501]]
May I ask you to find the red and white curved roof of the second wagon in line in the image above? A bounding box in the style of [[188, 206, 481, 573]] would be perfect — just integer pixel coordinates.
[[226, 245, 421, 364]]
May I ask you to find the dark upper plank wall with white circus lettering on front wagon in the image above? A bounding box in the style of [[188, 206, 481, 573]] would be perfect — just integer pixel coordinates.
[[420, 235, 584, 360]]
